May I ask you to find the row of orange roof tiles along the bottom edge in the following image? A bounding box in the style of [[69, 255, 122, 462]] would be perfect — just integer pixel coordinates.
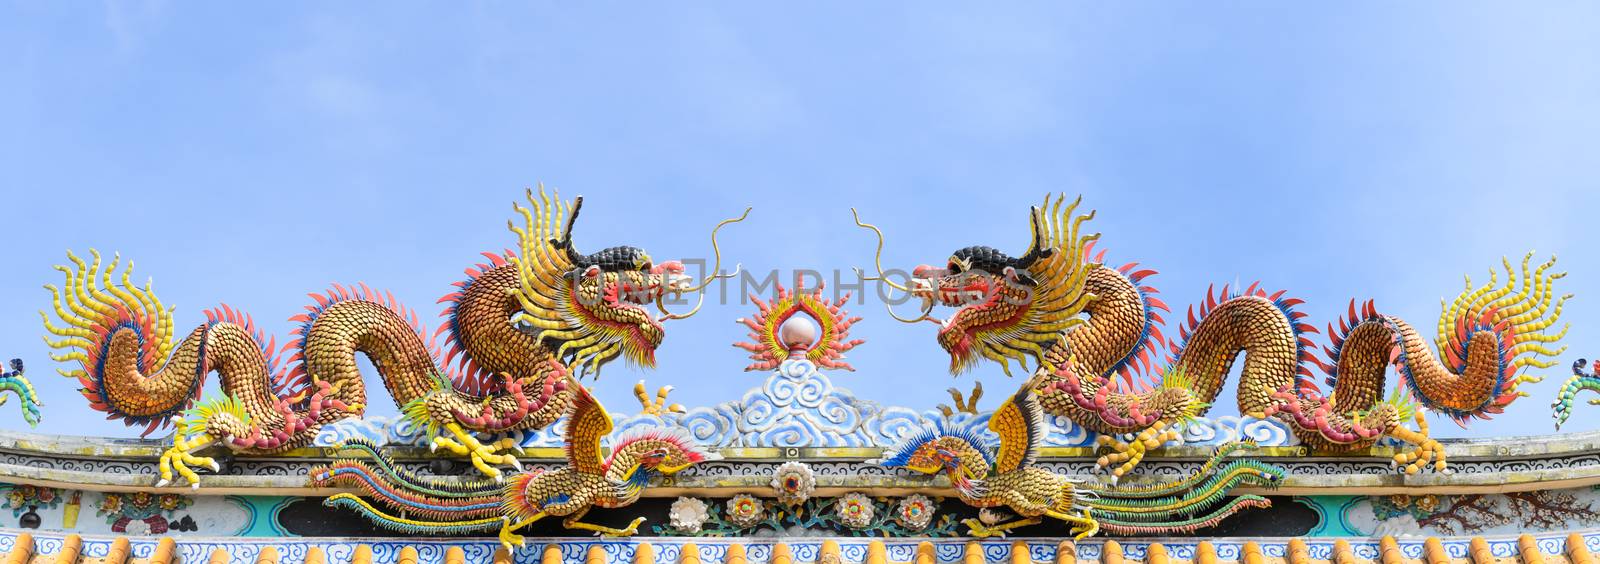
[[0, 530, 1600, 564]]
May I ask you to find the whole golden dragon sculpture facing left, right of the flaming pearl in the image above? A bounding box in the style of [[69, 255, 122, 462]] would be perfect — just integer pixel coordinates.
[[856, 195, 1570, 479]]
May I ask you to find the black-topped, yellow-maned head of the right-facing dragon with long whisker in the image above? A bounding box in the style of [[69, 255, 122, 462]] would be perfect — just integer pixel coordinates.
[[510, 187, 749, 373]]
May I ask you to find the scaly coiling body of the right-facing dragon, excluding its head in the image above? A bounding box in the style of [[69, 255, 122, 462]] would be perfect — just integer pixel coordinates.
[[46, 260, 566, 453]]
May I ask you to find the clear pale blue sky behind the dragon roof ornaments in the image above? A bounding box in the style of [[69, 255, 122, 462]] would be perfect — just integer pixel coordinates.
[[0, 2, 1600, 436]]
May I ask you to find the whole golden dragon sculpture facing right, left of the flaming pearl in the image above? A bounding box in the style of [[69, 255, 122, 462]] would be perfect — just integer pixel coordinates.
[[40, 187, 749, 487]]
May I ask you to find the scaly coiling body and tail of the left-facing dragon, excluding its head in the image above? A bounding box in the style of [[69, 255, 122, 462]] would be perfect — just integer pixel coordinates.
[[1042, 253, 1562, 450]]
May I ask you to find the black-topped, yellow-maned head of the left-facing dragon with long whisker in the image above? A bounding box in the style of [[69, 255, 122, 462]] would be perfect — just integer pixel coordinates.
[[856, 195, 1099, 373]]
